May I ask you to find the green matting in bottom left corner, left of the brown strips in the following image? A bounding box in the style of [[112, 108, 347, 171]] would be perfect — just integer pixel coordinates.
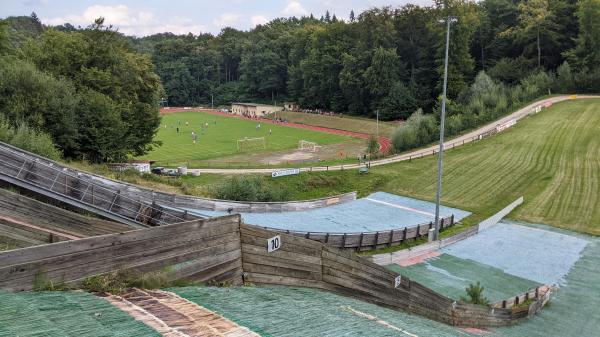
[[0, 291, 160, 337]]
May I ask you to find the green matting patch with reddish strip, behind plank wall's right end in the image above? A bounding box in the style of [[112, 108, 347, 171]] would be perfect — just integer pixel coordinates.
[[386, 254, 540, 302]]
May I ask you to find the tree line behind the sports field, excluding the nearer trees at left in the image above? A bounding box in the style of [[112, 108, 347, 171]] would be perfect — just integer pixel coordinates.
[[132, 0, 600, 120]]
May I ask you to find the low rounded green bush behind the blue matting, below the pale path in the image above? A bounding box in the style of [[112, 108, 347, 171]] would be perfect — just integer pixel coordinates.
[[213, 176, 289, 201]]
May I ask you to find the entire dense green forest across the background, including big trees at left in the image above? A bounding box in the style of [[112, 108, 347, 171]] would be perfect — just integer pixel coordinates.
[[0, 0, 600, 160]]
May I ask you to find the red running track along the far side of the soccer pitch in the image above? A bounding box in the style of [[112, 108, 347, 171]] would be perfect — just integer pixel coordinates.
[[160, 108, 392, 153]]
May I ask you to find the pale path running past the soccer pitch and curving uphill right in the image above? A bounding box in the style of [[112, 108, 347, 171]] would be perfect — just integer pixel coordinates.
[[164, 95, 600, 174]]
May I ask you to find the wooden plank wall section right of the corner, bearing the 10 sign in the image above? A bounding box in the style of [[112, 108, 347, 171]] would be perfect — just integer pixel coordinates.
[[240, 224, 539, 327]]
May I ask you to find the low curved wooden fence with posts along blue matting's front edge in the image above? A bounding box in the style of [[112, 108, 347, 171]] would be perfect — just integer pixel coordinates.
[[261, 215, 454, 251]]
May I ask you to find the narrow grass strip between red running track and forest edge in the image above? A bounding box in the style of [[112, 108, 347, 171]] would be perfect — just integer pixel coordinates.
[[277, 111, 398, 137]]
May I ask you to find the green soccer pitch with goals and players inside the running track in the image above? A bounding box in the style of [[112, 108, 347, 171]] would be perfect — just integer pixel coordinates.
[[137, 112, 350, 165]]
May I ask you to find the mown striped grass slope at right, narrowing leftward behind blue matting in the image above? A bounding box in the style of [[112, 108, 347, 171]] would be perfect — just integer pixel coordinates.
[[172, 99, 600, 235]]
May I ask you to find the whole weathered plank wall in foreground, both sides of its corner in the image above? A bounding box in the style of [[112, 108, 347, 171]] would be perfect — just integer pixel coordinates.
[[0, 215, 543, 327]]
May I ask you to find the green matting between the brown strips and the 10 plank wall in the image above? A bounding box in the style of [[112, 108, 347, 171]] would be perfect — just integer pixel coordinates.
[[168, 286, 468, 337]]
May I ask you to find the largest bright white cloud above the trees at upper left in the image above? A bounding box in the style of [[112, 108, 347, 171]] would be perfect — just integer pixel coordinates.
[[42, 5, 207, 36]]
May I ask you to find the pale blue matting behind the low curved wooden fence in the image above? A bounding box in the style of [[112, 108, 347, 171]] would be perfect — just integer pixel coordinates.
[[188, 192, 471, 233]]
